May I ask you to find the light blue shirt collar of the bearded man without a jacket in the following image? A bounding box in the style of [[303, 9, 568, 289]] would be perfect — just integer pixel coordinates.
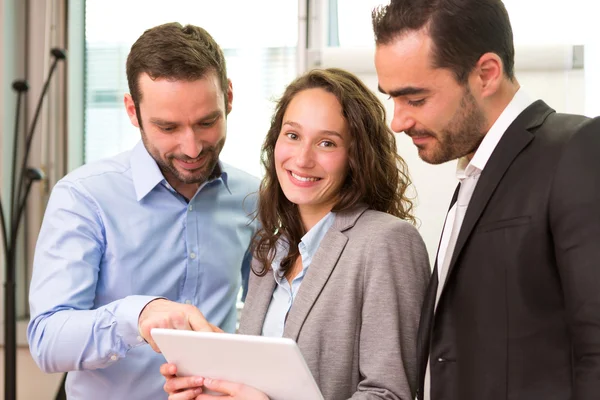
[[131, 140, 232, 201]]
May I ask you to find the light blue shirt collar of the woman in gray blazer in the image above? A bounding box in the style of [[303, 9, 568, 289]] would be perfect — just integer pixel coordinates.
[[272, 211, 335, 282]]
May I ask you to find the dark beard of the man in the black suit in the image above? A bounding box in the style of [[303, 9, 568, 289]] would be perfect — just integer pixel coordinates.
[[405, 88, 487, 164]]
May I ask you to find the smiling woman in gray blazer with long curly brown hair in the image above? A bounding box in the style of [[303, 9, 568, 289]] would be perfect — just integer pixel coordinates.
[[161, 69, 430, 400]]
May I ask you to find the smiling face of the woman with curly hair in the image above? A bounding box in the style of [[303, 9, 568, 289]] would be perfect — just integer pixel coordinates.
[[275, 88, 350, 220]]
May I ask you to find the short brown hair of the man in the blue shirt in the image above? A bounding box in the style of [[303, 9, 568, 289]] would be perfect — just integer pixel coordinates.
[[126, 22, 229, 126]]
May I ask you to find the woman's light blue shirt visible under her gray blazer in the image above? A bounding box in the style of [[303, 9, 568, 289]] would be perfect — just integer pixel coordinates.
[[262, 212, 335, 337]]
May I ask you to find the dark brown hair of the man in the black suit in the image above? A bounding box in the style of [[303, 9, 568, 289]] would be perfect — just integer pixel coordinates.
[[372, 0, 515, 83]]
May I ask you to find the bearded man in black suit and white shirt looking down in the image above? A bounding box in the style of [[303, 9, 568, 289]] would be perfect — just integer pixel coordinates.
[[373, 0, 600, 400]]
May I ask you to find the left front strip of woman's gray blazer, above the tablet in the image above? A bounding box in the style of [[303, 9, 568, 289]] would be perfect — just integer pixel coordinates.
[[240, 260, 277, 335]]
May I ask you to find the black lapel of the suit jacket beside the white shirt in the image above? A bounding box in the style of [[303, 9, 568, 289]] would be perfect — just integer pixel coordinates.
[[447, 100, 554, 286]]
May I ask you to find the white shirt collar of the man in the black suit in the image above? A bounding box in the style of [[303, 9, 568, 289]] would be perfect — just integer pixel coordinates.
[[456, 88, 533, 180]]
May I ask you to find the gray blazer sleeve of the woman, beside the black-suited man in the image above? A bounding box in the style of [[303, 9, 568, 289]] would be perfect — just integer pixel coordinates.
[[351, 220, 430, 400]]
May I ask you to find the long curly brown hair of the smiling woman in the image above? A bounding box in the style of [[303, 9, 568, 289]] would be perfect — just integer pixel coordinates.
[[254, 68, 414, 276]]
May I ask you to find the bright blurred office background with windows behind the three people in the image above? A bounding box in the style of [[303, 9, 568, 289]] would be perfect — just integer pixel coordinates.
[[0, 0, 600, 400]]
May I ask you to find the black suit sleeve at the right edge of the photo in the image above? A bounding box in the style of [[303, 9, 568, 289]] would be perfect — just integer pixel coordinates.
[[550, 118, 600, 400]]
